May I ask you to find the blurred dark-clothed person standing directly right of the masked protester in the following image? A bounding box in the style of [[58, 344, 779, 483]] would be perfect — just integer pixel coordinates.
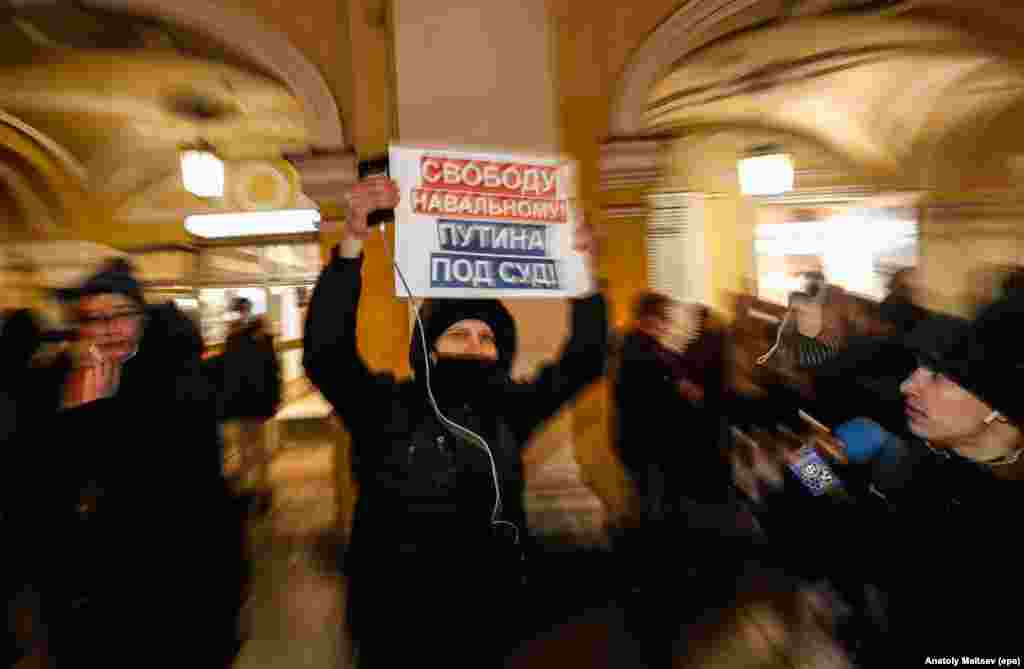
[[613, 292, 752, 667]]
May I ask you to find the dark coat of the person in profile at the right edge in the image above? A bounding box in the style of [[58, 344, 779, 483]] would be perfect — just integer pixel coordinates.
[[762, 432, 1024, 666]]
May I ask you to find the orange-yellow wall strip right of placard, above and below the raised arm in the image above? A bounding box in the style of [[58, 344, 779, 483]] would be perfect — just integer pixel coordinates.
[[551, 0, 681, 522]]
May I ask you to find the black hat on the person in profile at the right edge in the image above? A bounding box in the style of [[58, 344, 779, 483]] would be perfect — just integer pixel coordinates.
[[908, 296, 1024, 426]]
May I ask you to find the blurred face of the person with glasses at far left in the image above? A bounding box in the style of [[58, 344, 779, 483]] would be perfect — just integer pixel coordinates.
[[78, 293, 142, 362]]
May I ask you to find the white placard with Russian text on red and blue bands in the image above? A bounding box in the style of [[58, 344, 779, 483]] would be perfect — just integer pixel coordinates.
[[389, 147, 587, 298]]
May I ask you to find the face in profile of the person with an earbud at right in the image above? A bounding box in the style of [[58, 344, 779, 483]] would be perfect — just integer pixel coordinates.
[[900, 367, 992, 444]]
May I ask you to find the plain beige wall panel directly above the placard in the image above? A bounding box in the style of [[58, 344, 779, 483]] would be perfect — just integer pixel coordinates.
[[394, 0, 558, 152]]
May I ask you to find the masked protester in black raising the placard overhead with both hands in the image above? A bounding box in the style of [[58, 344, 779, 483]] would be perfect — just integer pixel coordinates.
[[303, 177, 608, 667]]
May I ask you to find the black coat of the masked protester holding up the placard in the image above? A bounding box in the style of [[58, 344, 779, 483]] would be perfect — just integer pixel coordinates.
[[303, 249, 607, 666]]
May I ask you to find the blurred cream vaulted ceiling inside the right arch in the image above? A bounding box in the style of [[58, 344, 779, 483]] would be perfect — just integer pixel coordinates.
[[643, 0, 1024, 184]]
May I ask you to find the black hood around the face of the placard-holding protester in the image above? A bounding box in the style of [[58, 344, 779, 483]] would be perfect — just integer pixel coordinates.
[[409, 299, 517, 373]]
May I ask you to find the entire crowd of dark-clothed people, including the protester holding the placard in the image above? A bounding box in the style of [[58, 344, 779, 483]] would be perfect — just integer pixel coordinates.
[[0, 171, 1024, 668]]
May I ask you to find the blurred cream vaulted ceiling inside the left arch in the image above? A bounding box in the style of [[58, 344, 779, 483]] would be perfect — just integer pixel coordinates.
[[0, 0, 329, 241]]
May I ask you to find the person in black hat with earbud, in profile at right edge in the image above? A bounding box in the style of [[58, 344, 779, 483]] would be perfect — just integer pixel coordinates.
[[733, 296, 1024, 666]]
